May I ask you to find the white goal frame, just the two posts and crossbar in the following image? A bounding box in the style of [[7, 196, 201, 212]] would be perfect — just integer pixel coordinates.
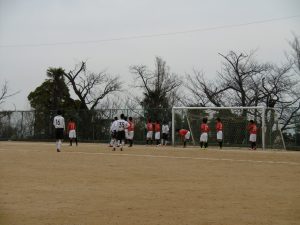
[[172, 106, 266, 150]]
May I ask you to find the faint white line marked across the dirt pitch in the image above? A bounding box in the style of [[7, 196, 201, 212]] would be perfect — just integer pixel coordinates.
[[62, 152, 300, 166]]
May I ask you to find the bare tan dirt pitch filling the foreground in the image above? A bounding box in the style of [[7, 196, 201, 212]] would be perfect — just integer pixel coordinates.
[[0, 142, 300, 225]]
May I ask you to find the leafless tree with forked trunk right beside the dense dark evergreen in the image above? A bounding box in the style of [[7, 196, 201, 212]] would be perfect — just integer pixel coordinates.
[[64, 62, 121, 110]]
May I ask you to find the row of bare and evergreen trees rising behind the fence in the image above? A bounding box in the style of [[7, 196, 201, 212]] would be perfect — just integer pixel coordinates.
[[0, 36, 300, 142]]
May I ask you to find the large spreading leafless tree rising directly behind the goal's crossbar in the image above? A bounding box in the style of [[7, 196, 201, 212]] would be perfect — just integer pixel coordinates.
[[186, 51, 270, 107]]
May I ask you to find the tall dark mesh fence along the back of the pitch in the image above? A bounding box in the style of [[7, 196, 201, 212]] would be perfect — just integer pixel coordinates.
[[0, 109, 300, 150]]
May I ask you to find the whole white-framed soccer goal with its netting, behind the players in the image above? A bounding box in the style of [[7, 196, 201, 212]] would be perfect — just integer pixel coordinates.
[[172, 106, 285, 150]]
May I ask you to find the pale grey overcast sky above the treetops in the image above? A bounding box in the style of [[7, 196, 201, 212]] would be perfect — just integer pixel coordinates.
[[0, 0, 300, 110]]
